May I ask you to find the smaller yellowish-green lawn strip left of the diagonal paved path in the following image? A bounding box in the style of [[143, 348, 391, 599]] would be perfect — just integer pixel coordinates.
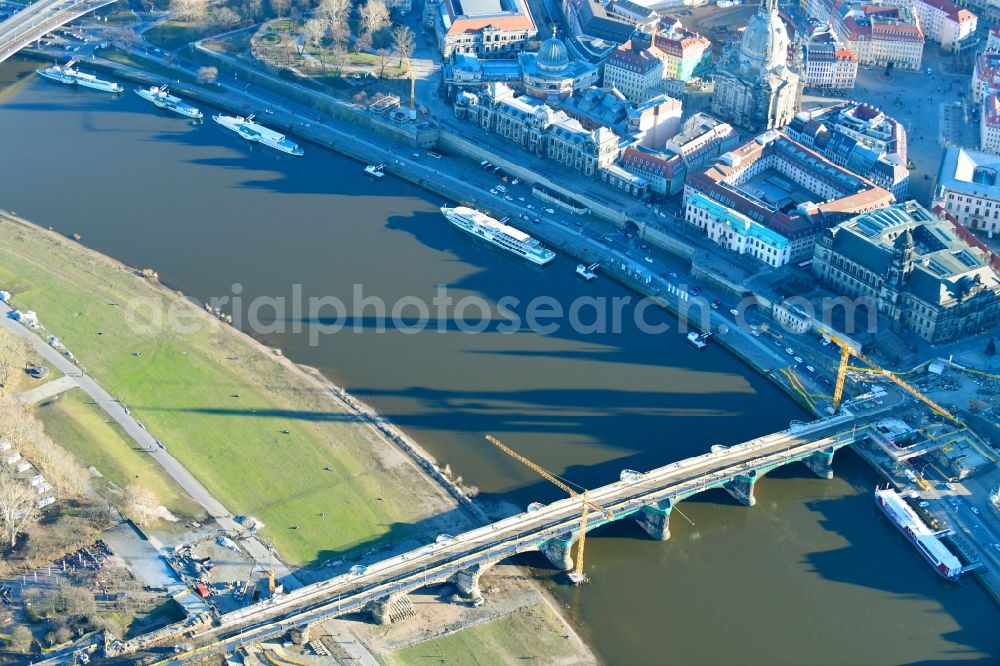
[[35, 389, 204, 520]]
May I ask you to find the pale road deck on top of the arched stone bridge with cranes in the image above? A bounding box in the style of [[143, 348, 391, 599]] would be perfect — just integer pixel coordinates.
[[131, 411, 881, 660]]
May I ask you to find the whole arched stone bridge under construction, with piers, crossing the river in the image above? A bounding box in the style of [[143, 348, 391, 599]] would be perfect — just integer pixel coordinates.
[[108, 405, 892, 661]]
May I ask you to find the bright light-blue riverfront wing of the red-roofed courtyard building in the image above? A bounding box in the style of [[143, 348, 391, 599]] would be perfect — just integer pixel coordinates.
[[684, 192, 792, 267]]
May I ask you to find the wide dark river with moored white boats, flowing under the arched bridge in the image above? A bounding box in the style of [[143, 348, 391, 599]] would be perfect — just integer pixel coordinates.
[[0, 60, 1000, 664]]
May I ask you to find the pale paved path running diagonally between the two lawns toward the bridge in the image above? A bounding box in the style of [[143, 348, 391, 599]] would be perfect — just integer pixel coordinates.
[[0, 302, 302, 589]]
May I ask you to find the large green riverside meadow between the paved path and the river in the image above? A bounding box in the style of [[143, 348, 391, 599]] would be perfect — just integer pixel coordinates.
[[0, 220, 452, 563]]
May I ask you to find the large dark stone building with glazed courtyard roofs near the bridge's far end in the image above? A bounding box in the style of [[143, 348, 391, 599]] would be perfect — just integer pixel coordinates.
[[812, 201, 1000, 344]]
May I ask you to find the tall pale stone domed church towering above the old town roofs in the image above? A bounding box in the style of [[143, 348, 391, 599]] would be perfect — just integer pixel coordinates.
[[712, 0, 801, 132]]
